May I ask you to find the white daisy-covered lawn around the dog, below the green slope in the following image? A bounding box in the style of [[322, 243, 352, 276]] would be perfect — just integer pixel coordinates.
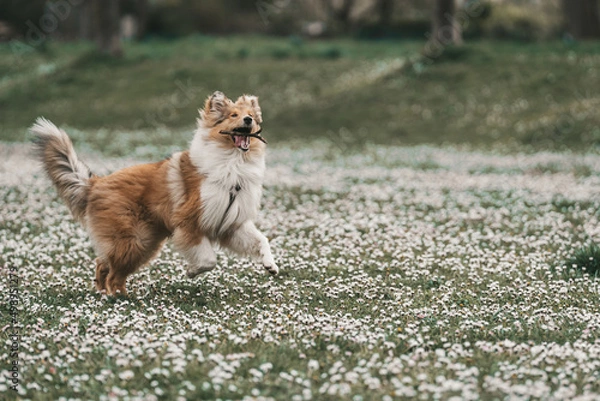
[[0, 144, 600, 400]]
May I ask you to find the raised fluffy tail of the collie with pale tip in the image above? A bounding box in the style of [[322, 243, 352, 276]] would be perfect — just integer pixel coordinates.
[[30, 117, 93, 221]]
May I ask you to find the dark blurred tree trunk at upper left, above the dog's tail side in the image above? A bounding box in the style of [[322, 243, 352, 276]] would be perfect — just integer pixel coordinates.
[[89, 0, 123, 57]]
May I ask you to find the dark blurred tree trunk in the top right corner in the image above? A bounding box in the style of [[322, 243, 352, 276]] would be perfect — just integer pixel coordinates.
[[562, 0, 600, 39]]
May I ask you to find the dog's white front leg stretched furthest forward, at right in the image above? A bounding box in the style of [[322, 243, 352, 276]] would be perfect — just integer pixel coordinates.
[[223, 221, 279, 275]]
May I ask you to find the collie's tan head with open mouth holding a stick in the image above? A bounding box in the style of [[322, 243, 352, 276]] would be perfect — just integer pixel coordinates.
[[200, 92, 264, 152]]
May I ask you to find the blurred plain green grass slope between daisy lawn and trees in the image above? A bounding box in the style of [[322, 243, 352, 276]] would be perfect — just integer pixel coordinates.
[[0, 36, 600, 155]]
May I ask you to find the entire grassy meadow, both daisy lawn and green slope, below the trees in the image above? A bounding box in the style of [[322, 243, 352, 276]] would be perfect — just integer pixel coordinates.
[[0, 38, 600, 401]]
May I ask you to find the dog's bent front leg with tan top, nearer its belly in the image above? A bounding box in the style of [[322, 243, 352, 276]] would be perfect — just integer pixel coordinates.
[[173, 229, 217, 278]]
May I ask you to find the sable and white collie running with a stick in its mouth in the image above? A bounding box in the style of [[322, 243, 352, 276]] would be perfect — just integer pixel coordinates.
[[31, 92, 278, 295]]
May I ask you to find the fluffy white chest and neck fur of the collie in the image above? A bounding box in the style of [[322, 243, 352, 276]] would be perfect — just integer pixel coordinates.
[[190, 130, 265, 238]]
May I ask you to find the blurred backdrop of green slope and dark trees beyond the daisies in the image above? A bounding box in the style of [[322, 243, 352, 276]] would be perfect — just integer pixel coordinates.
[[0, 0, 600, 155]]
